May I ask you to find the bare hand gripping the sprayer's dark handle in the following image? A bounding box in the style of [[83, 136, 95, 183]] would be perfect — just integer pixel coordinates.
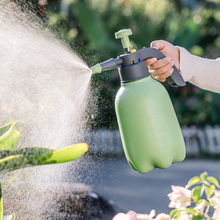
[[145, 40, 180, 82]]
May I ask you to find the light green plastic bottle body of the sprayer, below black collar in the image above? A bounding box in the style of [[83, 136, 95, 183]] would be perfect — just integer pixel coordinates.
[[115, 76, 185, 173]]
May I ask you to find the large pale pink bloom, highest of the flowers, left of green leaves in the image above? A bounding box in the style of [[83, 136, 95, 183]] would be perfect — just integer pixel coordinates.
[[168, 186, 192, 209]]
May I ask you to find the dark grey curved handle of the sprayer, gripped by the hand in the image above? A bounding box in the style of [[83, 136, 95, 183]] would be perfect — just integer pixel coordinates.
[[138, 47, 186, 87]]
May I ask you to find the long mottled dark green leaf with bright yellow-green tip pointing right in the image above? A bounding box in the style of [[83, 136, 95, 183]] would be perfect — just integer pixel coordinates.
[[0, 143, 88, 172]]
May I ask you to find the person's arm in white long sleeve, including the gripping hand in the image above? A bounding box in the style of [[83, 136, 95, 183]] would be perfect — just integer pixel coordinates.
[[145, 40, 220, 93]]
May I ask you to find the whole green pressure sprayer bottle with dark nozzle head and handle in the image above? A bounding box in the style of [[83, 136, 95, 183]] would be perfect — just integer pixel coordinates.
[[91, 29, 185, 173]]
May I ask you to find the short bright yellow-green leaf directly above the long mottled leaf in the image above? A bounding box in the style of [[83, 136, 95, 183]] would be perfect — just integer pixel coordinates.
[[0, 130, 20, 150]]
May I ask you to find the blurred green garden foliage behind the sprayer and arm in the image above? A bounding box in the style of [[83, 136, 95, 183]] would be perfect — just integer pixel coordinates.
[[49, 0, 220, 128]]
